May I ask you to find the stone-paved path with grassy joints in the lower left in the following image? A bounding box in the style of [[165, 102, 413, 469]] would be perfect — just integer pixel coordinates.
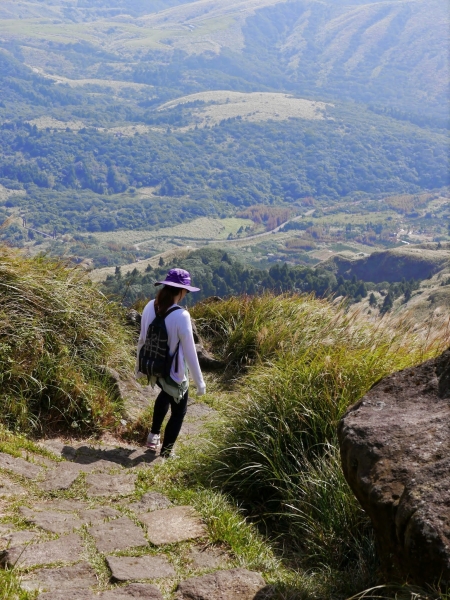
[[0, 404, 270, 600]]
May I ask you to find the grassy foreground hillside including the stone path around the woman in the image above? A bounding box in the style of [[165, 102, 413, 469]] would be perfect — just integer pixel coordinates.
[[0, 248, 448, 600]]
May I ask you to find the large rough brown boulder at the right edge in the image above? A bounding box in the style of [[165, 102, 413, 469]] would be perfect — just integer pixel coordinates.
[[338, 351, 450, 586]]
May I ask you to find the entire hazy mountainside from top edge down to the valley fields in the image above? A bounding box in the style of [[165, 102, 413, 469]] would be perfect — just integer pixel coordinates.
[[0, 0, 449, 244]]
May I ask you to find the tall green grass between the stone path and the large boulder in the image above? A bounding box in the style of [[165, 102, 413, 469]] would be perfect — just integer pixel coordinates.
[[192, 295, 449, 594]]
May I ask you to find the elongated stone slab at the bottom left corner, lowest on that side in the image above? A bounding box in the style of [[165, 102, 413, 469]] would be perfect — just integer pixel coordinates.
[[21, 562, 98, 592]]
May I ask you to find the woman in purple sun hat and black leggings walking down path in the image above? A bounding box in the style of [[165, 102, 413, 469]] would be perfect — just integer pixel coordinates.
[[136, 269, 206, 458]]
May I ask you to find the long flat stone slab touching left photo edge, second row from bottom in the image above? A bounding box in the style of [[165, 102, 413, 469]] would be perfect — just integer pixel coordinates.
[[0, 534, 83, 567]]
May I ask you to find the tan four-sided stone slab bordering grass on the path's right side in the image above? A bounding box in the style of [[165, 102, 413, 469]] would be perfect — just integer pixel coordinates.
[[138, 506, 207, 546]]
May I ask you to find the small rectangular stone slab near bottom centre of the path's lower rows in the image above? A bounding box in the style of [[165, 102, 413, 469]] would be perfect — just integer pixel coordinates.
[[106, 556, 175, 581]]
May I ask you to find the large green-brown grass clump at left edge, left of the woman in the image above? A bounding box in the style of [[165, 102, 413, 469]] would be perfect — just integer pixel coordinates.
[[0, 247, 131, 432]]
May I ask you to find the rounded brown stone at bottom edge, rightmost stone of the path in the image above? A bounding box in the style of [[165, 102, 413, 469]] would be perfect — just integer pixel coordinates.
[[175, 569, 270, 600]]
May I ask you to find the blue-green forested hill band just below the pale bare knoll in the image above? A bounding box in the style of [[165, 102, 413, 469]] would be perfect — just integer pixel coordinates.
[[0, 97, 449, 233]]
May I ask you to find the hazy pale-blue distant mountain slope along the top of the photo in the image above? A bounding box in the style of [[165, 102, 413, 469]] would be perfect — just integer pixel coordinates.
[[0, 0, 450, 119]]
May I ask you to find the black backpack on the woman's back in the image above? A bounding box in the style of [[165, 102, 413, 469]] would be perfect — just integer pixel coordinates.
[[139, 306, 181, 381]]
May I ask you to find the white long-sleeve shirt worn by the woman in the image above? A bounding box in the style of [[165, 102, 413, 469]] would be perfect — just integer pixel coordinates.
[[136, 300, 206, 394]]
